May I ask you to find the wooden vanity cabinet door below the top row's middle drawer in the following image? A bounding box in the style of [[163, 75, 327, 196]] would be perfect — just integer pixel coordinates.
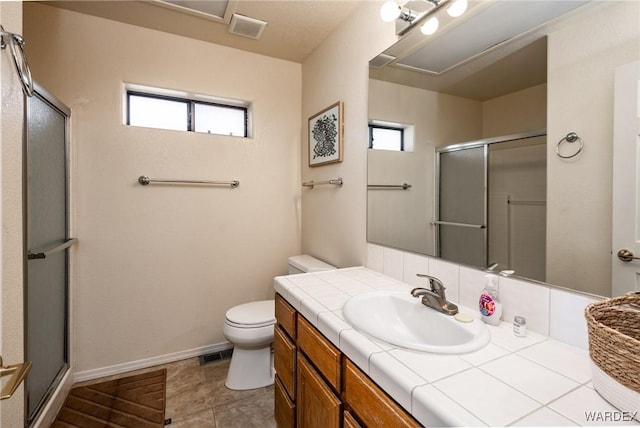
[[296, 354, 342, 428]]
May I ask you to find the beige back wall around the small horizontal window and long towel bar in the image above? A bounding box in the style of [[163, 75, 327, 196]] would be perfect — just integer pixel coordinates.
[[25, 3, 301, 372]]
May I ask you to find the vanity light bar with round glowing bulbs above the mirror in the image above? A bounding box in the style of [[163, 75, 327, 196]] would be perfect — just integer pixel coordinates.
[[380, 0, 468, 36]]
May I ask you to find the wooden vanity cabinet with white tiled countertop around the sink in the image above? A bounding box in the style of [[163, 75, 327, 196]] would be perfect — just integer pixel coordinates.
[[274, 267, 616, 427]]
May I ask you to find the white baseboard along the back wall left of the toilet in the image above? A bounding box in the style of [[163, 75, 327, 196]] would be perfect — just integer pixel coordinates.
[[73, 342, 233, 383]]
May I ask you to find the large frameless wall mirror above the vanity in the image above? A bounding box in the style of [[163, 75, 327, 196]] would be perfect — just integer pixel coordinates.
[[367, 0, 640, 296]]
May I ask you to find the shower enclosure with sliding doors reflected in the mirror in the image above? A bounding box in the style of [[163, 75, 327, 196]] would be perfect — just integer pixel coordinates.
[[435, 131, 546, 281]]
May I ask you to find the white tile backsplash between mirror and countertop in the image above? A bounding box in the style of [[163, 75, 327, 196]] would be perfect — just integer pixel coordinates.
[[367, 244, 597, 349]]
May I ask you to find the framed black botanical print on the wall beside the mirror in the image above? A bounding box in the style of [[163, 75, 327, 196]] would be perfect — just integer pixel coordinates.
[[309, 101, 344, 167]]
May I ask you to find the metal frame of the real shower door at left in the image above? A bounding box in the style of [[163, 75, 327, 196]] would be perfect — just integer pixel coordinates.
[[22, 82, 72, 427]]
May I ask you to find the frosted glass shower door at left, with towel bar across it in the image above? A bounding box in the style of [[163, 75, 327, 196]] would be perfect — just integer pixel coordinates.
[[24, 84, 70, 425]]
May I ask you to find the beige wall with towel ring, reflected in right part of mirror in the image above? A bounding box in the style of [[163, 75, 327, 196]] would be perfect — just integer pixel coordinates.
[[547, 1, 640, 295]]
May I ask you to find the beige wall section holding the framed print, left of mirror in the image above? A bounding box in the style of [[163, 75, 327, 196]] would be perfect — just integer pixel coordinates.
[[298, 1, 396, 267]]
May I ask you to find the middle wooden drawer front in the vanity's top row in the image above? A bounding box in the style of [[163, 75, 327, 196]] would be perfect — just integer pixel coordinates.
[[297, 317, 341, 392]]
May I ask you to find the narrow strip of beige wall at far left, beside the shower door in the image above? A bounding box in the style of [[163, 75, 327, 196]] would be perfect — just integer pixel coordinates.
[[0, 2, 24, 427]]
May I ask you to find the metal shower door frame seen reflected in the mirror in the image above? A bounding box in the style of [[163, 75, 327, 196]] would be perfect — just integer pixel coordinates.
[[434, 128, 547, 266]]
